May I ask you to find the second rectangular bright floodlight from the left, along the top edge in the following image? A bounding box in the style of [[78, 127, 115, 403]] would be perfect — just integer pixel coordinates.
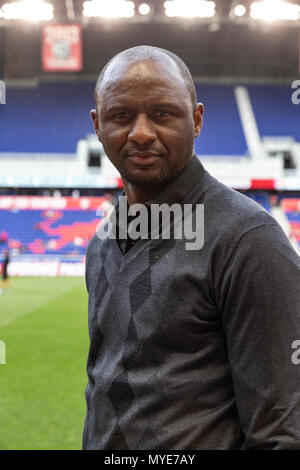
[[83, 0, 135, 18]]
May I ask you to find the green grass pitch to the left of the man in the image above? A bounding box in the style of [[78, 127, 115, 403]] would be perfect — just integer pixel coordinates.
[[0, 278, 89, 450]]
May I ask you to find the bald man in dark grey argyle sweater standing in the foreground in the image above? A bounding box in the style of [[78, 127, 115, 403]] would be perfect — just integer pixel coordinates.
[[83, 46, 300, 450]]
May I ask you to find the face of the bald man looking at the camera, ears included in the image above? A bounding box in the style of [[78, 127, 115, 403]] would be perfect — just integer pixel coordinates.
[[91, 57, 203, 185]]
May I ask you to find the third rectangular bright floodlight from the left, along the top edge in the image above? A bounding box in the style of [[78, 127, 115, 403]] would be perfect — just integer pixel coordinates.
[[164, 0, 216, 18]]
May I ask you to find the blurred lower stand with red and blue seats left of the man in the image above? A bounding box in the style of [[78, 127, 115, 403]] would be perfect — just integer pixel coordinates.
[[0, 197, 112, 258]]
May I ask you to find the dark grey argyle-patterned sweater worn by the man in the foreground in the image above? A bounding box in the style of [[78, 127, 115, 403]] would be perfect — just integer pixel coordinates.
[[83, 157, 300, 450]]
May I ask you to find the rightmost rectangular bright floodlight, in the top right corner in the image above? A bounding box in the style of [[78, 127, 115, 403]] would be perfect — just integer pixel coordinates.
[[250, 0, 300, 21]]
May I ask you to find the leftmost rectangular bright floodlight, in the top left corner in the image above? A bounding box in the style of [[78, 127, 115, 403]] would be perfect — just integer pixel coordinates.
[[2, 0, 53, 21]]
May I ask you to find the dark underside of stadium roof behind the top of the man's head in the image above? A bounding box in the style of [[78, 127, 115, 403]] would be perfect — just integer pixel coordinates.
[[0, 0, 300, 82]]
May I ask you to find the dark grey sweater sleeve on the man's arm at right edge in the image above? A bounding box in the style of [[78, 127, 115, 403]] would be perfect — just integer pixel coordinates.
[[219, 222, 300, 449]]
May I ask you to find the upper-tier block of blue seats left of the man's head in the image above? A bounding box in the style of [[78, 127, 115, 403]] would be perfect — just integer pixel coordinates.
[[0, 83, 93, 153]]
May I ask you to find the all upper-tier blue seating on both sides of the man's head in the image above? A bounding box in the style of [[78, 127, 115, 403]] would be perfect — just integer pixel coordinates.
[[0, 82, 300, 156]]
